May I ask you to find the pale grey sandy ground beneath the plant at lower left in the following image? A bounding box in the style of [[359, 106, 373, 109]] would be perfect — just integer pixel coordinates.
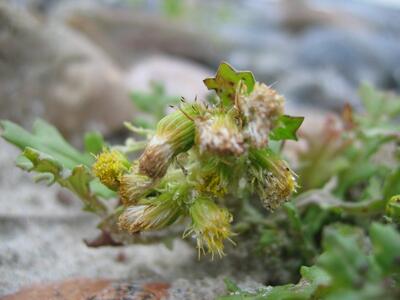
[[0, 139, 262, 299]]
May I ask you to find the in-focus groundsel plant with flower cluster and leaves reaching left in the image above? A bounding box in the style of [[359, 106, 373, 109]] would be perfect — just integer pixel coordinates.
[[2, 63, 303, 257]]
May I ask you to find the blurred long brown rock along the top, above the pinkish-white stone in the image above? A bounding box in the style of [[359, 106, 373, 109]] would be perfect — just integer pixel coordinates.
[[52, 2, 223, 68]]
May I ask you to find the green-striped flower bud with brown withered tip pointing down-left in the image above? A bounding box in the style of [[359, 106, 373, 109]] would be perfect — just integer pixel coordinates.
[[139, 104, 198, 178]]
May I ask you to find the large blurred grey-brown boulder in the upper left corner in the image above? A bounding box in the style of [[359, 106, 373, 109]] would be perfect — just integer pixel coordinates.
[[0, 2, 133, 136]]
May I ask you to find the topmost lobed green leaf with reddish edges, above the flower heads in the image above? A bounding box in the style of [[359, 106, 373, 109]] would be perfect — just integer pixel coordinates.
[[203, 62, 256, 105]]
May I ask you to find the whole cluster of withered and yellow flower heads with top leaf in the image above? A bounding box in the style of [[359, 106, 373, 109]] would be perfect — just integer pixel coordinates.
[[93, 65, 297, 256]]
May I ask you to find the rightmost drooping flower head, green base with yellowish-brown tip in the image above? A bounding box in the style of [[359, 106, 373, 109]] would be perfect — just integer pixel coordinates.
[[249, 149, 297, 210]]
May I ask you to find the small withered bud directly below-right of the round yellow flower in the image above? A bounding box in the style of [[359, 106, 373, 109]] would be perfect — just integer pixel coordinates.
[[119, 161, 157, 205]]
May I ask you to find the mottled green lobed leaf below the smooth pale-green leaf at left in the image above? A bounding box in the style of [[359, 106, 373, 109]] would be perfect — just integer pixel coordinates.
[[19, 147, 106, 214]]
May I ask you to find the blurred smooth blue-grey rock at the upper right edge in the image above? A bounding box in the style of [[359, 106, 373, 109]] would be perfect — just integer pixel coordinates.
[[297, 28, 400, 85]]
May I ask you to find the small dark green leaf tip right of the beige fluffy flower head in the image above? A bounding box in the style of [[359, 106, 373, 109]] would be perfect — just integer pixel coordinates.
[[269, 115, 304, 141]]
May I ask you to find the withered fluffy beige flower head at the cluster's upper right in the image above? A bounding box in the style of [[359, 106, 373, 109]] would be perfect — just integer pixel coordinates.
[[238, 83, 285, 149]]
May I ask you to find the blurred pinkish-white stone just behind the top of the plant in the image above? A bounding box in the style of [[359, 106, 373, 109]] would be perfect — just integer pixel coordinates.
[[125, 55, 215, 100]]
